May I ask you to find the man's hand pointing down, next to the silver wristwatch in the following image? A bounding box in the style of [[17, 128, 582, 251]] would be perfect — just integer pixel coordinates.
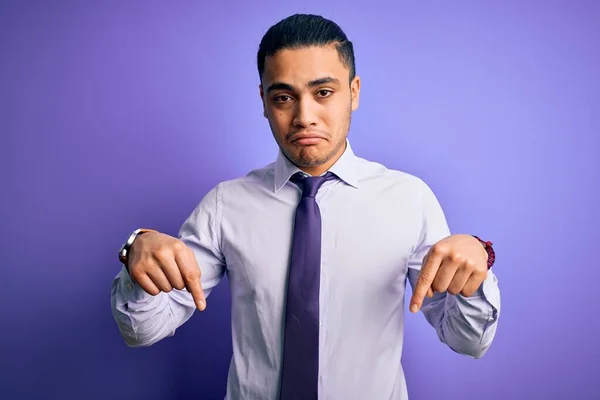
[[127, 232, 206, 311]]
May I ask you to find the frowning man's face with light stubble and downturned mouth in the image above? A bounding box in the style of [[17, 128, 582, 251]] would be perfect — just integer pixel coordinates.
[[260, 45, 360, 175]]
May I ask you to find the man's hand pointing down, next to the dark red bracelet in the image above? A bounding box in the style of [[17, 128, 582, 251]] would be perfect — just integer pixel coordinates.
[[410, 234, 488, 313]]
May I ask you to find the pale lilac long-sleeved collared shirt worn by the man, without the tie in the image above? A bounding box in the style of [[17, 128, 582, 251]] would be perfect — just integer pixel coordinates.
[[112, 140, 500, 400]]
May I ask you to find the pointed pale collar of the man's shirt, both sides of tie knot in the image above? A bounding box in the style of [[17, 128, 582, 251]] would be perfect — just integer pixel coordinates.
[[273, 138, 359, 192]]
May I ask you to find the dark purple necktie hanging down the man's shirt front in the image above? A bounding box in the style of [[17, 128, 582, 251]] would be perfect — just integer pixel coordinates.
[[280, 172, 336, 400]]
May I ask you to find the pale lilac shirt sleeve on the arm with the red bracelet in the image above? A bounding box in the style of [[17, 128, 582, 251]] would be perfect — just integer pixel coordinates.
[[408, 182, 500, 358]]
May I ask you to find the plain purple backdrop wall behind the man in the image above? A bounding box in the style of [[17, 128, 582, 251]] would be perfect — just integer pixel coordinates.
[[0, 0, 600, 400]]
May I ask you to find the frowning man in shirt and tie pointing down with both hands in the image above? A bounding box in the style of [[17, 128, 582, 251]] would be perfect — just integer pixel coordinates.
[[112, 15, 500, 400]]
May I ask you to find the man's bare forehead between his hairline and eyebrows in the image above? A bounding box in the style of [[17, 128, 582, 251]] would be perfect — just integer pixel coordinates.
[[263, 45, 350, 86]]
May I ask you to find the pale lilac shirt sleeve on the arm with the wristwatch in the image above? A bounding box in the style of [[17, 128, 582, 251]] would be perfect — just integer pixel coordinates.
[[111, 186, 226, 347]]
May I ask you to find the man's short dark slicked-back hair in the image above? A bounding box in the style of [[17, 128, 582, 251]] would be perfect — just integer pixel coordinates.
[[256, 14, 356, 81]]
